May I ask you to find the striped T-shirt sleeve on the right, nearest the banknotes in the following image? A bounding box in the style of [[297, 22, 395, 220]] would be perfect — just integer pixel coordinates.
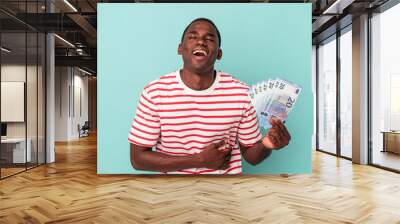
[[238, 98, 262, 147]]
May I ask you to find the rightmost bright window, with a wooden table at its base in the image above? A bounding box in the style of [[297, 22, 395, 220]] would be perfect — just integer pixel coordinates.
[[370, 4, 400, 171]]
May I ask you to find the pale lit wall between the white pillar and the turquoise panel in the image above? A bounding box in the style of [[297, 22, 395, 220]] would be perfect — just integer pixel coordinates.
[[55, 67, 88, 141]]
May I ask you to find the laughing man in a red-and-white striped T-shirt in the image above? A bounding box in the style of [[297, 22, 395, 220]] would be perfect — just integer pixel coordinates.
[[128, 18, 290, 174]]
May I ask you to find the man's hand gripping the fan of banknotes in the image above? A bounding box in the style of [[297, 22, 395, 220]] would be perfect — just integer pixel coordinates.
[[262, 118, 290, 149]]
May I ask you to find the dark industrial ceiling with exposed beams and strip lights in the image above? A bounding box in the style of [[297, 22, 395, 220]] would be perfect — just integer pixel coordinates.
[[0, 0, 394, 73]]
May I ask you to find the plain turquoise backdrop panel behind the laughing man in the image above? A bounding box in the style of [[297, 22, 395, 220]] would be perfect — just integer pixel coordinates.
[[97, 3, 313, 174]]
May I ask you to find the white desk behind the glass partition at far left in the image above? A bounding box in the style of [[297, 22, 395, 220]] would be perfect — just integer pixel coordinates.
[[1, 138, 32, 163]]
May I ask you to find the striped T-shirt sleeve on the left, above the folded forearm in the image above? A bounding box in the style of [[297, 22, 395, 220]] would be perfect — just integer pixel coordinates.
[[128, 90, 160, 147]]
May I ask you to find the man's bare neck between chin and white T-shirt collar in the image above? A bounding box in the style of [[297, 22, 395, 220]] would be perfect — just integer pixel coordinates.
[[180, 68, 215, 90]]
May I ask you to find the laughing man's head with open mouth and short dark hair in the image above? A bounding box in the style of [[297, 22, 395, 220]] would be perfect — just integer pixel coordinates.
[[178, 20, 222, 74]]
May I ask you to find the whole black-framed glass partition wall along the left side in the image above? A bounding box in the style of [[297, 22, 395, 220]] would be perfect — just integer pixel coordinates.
[[0, 1, 46, 179]]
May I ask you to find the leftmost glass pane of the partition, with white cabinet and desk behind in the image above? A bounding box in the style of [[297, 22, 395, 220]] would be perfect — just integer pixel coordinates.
[[0, 32, 30, 178]]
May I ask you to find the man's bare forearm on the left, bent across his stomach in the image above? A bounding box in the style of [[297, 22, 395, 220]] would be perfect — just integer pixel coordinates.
[[131, 151, 202, 172]]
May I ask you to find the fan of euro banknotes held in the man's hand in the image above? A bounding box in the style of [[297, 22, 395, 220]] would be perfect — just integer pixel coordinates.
[[249, 78, 302, 129]]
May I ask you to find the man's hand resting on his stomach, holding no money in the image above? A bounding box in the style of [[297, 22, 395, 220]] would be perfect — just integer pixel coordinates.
[[198, 140, 232, 170]]
